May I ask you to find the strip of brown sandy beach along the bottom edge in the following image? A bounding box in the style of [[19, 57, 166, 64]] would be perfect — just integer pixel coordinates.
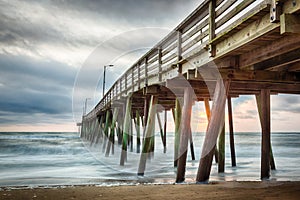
[[0, 181, 300, 200]]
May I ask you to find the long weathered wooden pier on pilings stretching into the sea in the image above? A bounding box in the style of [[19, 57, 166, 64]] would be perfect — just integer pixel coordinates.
[[81, 0, 300, 182]]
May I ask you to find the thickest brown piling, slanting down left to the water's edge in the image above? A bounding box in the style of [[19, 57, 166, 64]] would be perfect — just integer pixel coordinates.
[[196, 79, 229, 182]]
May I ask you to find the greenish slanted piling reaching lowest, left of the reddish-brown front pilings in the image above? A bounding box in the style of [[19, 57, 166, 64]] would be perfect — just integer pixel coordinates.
[[137, 95, 157, 176]]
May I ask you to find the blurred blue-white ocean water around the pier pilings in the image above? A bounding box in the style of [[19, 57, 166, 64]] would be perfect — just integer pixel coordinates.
[[0, 132, 300, 187]]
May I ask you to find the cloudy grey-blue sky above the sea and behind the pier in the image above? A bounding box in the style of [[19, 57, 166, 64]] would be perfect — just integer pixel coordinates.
[[0, 0, 300, 131]]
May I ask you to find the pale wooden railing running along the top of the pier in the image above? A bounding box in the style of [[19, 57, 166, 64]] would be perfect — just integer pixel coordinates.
[[84, 0, 268, 119]]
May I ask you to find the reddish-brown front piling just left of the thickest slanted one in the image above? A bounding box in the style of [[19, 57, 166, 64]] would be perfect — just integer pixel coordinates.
[[176, 87, 193, 183]]
